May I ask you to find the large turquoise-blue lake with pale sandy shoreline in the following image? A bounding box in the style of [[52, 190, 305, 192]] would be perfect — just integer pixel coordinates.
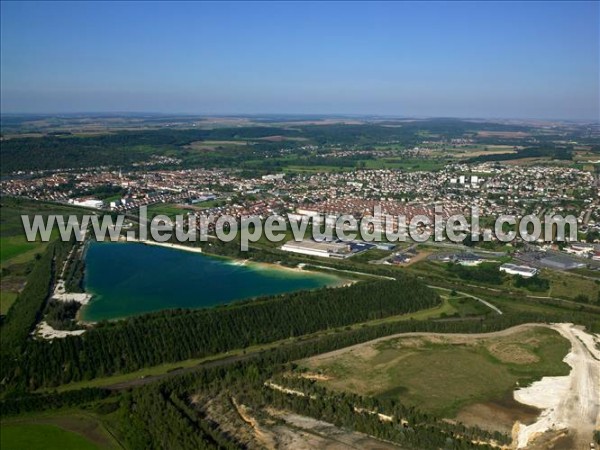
[[81, 243, 341, 322]]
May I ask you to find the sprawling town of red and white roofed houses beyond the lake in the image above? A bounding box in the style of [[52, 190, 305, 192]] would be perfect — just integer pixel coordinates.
[[1, 153, 600, 268]]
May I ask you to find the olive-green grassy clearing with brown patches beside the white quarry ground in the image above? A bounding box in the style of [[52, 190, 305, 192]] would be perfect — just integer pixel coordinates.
[[298, 327, 569, 432]]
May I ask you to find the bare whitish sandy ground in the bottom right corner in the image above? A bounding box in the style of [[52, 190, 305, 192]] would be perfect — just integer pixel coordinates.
[[514, 323, 600, 450]]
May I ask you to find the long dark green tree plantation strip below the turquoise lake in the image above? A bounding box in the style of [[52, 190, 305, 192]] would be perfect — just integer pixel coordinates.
[[2, 266, 440, 387]]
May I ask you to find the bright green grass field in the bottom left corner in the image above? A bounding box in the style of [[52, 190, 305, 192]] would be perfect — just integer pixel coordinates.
[[0, 424, 100, 450]]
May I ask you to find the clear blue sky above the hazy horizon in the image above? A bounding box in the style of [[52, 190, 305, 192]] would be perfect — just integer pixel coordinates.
[[0, 1, 600, 120]]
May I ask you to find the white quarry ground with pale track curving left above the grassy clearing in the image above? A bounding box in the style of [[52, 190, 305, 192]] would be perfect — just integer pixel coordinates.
[[300, 323, 600, 450]]
